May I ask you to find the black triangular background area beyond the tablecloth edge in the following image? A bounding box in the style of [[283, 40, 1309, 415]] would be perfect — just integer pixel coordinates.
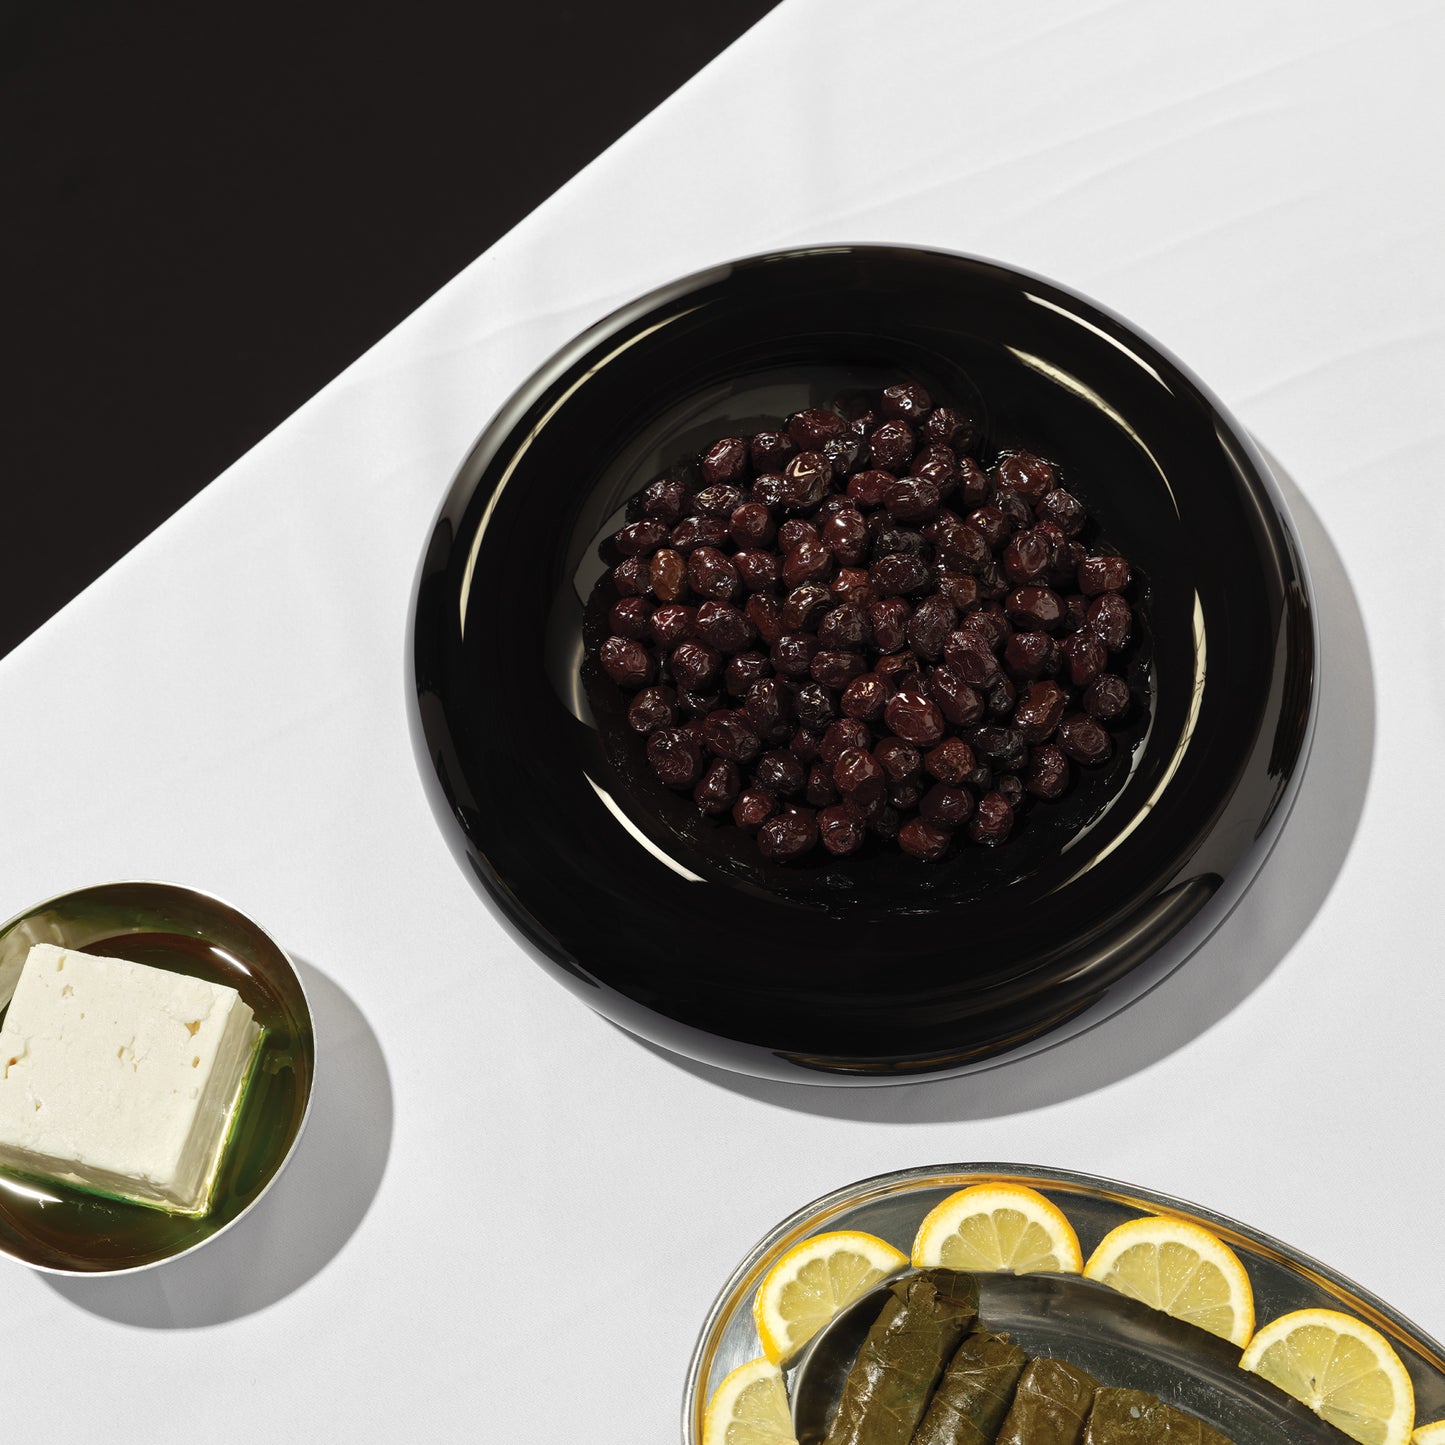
[[0, 0, 776, 653]]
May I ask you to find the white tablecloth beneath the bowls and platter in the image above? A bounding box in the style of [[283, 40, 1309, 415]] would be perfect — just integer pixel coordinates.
[[0, 0, 1445, 1445]]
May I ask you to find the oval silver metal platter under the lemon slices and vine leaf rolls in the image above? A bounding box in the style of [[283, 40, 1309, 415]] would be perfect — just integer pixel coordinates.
[[682, 1163, 1445, 1445]]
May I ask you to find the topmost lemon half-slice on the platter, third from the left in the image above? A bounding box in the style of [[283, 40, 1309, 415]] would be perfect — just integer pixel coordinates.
[[913, 1183, 1084, 1274]]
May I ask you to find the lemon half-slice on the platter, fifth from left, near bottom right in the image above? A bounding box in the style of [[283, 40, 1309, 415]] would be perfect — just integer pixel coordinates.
[[1240, 1309, 1415, 1445]]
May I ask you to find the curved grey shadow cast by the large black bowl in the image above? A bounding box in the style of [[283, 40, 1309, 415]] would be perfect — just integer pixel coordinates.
[[643, 441, 1374, 1124]]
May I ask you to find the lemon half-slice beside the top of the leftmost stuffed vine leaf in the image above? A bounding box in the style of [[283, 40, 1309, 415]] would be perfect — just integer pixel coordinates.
[[753, 1230, 907, 1364]]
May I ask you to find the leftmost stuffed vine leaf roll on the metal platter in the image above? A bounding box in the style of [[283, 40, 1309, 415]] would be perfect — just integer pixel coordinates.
[[824, 1269, 978, 1445]]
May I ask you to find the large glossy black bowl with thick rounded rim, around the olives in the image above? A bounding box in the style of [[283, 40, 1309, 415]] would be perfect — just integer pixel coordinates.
[[412, 246, 1315, 1082]]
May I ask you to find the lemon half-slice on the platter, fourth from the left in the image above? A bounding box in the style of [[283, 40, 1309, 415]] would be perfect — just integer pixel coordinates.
[[1084, 1215, 1254, 1345]]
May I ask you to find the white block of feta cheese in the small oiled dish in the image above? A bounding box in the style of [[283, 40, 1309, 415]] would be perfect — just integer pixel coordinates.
[[0, 944, 262, 1214]]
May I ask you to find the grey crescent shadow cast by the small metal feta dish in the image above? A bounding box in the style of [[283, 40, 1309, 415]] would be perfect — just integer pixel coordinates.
[[43, 958, 393, 1329]]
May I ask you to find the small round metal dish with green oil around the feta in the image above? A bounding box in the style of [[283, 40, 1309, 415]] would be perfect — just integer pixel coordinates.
[[0, 881, 316, 1276]]
